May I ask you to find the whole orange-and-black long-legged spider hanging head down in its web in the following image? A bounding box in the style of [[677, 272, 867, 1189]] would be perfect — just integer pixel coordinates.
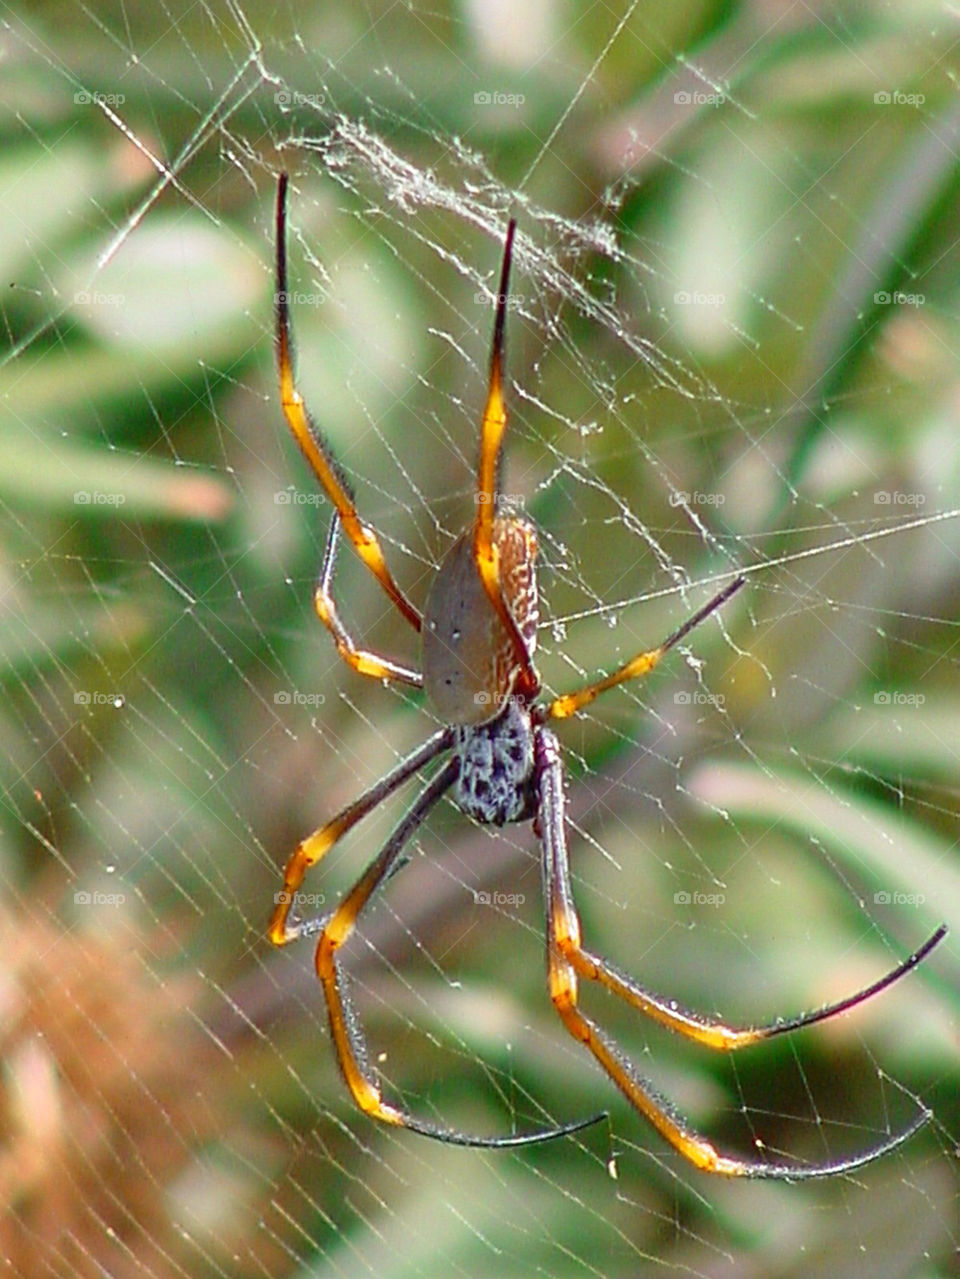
[[268, 174, 946, 1181]]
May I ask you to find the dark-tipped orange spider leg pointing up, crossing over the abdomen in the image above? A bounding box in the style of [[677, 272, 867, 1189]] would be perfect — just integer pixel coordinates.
[[473, 217, 539, 697]]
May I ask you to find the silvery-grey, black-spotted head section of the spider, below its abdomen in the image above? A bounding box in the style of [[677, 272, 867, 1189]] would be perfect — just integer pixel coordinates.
[[454, 700, 537, 826]]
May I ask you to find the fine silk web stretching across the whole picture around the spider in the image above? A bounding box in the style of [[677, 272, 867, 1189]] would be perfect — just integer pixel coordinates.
[[0, 3, 960, 1279]]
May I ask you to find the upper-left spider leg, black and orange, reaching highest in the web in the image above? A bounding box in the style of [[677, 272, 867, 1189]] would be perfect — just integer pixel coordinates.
[[275, 173, 421, 631]]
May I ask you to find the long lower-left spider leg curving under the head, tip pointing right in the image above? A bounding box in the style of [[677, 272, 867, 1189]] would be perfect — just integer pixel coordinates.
[[313, 746, 603, 1147]]
